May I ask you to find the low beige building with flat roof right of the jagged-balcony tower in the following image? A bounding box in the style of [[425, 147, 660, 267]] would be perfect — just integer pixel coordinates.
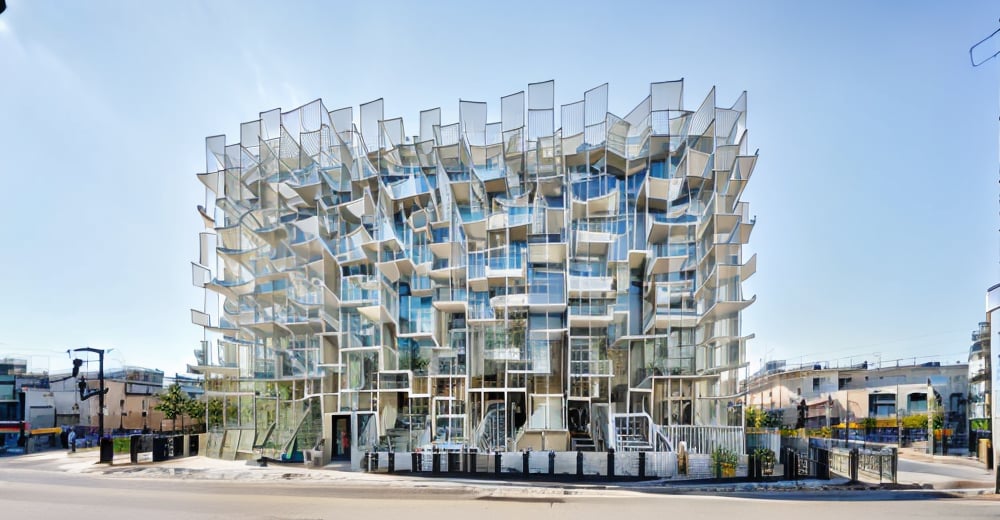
[[747, 362, 969, 436]]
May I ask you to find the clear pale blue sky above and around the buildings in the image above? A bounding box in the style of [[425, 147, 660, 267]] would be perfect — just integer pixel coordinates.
[[0, 0, 1000, 375]]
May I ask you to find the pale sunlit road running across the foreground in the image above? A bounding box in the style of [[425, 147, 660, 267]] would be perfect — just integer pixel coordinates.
[[0, 466, 1000, 520]]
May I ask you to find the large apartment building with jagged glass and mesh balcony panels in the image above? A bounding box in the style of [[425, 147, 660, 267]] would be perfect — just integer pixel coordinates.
[[192, 81, 757, 458]]
